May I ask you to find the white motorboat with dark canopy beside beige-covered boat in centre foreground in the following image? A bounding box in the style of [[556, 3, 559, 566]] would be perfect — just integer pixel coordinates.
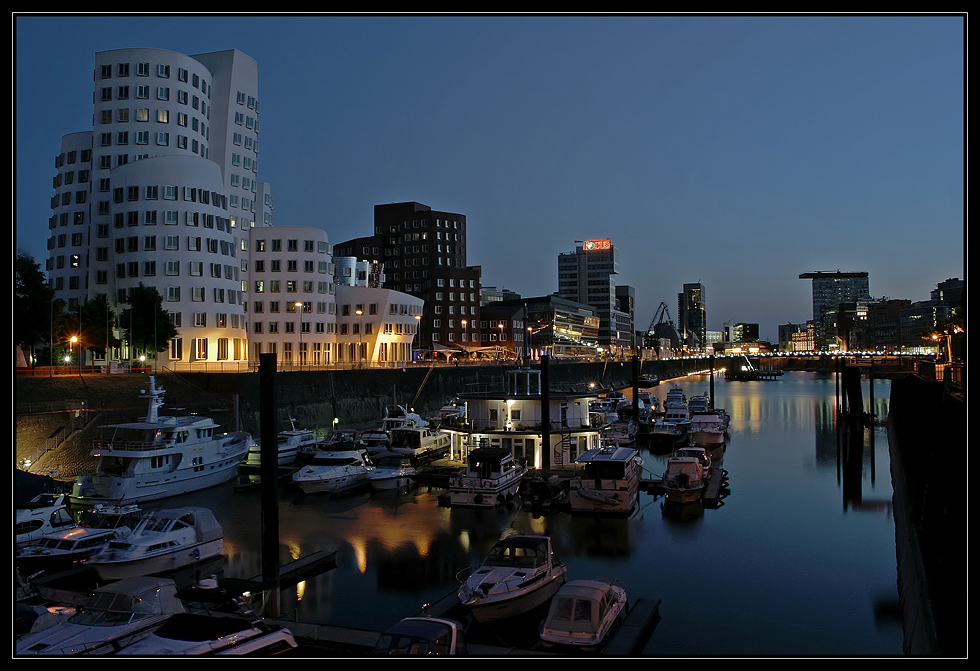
[[457, 534, 568, 622]]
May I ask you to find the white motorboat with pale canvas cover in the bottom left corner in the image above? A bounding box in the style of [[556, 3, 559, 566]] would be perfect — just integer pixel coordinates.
[[17, 577, 185, 655]]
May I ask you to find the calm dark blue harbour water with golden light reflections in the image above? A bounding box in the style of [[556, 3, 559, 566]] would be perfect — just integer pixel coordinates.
[[145, 372, 903, 656]]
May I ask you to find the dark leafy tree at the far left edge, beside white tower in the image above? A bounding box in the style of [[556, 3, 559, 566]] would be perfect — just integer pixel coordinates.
[[13, 252, 57, 368]]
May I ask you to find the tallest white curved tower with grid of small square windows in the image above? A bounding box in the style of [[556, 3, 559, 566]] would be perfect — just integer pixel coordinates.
[[47, 49, 262, 363]]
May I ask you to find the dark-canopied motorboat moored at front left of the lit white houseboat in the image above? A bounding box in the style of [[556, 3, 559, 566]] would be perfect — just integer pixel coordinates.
[[449, 447, 527, 508]]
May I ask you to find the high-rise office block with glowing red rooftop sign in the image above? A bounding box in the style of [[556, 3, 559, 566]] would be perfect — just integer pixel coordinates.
[[557, 240, 634, 354]]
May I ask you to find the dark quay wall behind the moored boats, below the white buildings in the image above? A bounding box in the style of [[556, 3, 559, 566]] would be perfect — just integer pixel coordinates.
[[15, 359, 723, 478]]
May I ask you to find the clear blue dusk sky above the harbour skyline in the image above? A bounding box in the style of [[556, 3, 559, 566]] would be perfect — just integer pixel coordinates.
[[12, 15, 966, 340]]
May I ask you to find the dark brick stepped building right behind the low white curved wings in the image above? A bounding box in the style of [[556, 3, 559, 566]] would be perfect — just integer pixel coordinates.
[[334, 202, 482, 350]]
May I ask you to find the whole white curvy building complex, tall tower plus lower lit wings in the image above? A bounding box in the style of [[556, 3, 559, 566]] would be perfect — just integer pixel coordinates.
[[46, 49, 422, 370]]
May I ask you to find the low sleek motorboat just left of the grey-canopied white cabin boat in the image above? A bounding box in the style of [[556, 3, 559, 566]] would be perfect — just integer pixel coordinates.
[[16, 504, 143, 573]]
